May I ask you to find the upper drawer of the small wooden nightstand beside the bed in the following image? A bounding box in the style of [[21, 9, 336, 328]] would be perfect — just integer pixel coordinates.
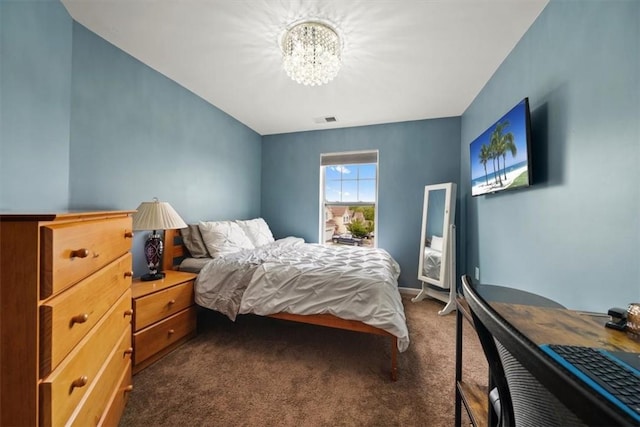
[[133, 281, 193, 332]]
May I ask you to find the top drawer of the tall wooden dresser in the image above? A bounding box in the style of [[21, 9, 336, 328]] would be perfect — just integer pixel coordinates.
[[40, 217, 133, 298]]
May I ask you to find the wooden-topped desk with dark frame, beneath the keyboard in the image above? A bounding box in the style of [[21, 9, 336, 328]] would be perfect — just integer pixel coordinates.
[[455, 285, 640, 426]]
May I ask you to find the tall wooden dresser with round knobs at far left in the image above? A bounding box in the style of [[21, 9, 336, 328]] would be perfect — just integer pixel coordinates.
[[0, 211, 133, 426]]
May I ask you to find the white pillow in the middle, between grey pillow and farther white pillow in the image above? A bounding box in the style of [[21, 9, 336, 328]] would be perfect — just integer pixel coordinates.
[[198, 221, 255, 258]]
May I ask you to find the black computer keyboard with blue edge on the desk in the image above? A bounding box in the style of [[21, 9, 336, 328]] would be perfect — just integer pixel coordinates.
[[541, 344, 640, 422]]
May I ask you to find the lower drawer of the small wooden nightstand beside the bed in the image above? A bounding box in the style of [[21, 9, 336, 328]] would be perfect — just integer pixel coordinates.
[[133, 306, 197, 364]]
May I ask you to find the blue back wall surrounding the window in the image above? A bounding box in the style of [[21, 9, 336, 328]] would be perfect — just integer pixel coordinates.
[[261, 117, 460, 288]]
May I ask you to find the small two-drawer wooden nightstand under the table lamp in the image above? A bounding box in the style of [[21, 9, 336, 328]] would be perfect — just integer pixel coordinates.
[[132, 271, 197, 373]]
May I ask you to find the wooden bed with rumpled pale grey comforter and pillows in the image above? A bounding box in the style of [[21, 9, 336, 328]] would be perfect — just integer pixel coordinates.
[[163, 218, 409, 381]]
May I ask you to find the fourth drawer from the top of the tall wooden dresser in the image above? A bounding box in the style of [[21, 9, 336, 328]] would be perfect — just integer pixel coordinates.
[[67, 328, 133, 427]]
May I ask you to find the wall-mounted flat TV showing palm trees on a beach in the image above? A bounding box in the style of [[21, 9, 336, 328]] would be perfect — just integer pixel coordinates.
[[469, 98, 531, 196]]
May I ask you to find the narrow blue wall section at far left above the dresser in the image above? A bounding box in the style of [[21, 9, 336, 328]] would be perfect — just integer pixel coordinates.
[[0, 0, 73, 211]]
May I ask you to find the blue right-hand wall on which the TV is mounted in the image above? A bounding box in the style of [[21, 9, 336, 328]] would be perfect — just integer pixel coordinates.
[[461, 0, 640, 312]]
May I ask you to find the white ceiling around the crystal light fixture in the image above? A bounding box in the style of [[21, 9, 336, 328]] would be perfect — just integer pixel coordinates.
[[62, 0, 548, 135]]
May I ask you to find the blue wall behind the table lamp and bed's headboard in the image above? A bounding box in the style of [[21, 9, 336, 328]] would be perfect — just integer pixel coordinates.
[[70, 23, 261, 275]]
